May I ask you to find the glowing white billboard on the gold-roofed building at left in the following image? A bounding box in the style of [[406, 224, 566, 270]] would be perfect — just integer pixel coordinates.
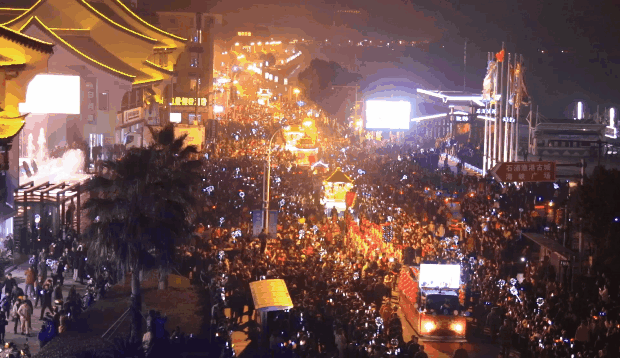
[[19, 74, 81, 114]]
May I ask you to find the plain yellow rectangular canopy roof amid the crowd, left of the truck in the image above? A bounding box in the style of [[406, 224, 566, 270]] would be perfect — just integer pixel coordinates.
[[250, 279, 293, 312]]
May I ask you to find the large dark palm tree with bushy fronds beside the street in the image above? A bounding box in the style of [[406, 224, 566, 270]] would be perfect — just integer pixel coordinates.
[[85, 126, 200, 341]]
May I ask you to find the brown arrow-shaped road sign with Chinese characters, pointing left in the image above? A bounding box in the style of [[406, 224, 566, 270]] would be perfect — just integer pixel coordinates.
[[490, 162, 555, 182]]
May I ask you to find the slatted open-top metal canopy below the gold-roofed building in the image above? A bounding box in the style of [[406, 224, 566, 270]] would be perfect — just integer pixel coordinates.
[[15, 179, 88, 233]]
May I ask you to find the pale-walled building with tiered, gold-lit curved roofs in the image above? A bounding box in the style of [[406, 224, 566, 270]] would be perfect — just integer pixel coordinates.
[[0, 0, 212, 152]]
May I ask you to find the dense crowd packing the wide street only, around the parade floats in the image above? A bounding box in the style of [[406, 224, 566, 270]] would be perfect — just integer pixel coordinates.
[[186, 107, 618, 357]]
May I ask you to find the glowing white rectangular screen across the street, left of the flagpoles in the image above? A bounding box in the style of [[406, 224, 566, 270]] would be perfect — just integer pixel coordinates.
[[366, 100, 411, 130]]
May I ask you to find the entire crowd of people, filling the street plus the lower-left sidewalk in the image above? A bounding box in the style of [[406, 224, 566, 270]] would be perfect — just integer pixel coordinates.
[[0, 95, 620, 358]]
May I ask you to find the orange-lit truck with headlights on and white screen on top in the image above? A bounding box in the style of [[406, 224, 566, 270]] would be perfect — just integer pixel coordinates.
[[398, 264, 468, 340]]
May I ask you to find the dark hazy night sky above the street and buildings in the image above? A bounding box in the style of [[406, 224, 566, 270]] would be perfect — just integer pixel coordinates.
[[0, 0, 620, 117]]
